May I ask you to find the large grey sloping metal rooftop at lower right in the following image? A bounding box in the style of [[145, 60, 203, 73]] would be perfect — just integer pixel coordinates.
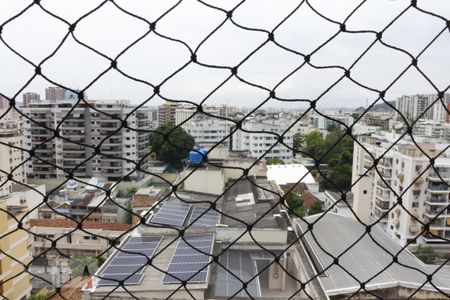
[[296, 213, 450, 296]]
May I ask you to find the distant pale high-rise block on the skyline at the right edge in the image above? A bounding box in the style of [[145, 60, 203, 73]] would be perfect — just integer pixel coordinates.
[[395, 94, 450, 122]]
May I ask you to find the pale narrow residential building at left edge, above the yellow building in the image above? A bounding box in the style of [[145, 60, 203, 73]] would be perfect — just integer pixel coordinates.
[[0, 112, 28, 196]]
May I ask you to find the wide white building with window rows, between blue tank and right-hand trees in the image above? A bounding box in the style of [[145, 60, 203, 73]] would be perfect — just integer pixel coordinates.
[[232, 119, 294, 163]]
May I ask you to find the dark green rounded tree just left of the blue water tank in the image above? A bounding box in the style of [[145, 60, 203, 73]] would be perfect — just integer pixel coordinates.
[[150, 124, 195, 168]]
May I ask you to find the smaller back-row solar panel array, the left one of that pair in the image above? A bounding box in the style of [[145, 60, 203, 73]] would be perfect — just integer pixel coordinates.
[[151, 201, 191, 226]]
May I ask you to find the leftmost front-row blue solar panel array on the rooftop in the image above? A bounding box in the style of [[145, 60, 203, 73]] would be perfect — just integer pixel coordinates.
[[97, 236, 162, 286]]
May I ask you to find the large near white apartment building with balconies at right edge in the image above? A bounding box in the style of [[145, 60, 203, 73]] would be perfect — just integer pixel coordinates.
[[352, 132, 450, 246]]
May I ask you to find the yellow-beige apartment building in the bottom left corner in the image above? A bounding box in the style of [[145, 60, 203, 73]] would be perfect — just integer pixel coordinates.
[[0, 198, 32, 299]]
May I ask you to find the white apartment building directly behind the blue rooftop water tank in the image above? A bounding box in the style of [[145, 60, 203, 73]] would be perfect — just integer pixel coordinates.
[[182, 118, 230, 145]]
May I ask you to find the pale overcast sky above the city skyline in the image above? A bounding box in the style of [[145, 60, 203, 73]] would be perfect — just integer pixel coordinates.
[[0, 0, 450, 108]]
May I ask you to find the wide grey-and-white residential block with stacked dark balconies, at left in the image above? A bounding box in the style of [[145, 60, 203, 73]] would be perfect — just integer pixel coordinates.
[[24, 100, 150, 181]]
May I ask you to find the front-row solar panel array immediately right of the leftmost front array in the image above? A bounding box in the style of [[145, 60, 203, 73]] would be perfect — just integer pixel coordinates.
[[163, 234, 214, 284]]
